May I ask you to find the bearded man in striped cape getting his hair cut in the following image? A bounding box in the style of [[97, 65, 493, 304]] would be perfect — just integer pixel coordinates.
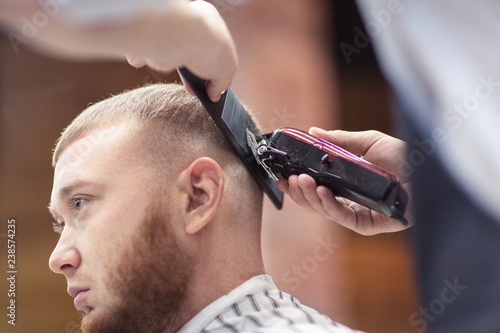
[[49, 84, 360, 332]]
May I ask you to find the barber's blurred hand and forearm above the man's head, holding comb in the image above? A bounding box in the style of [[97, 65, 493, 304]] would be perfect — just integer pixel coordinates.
[[0, 0, 238, 101]]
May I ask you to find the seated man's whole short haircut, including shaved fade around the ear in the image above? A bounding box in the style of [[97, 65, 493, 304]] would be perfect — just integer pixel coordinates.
[[52, 84, 262, 203]]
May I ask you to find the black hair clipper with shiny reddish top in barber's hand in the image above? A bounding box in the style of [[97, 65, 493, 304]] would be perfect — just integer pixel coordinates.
[[247, 128, 408, 225]]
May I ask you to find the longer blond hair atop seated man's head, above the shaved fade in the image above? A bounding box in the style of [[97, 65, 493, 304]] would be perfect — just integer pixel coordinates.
[[52, 84, 232, 167]]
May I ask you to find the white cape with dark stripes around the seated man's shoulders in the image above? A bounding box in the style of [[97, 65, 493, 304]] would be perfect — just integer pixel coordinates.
[[178, 274, 359, 333]]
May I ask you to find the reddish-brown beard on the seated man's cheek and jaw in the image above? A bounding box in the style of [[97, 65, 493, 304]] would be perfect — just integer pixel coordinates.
[[82, 204, 192, 333]]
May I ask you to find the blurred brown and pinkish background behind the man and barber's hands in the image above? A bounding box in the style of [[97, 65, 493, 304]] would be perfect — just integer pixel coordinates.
[[0, 0, 419, 333]]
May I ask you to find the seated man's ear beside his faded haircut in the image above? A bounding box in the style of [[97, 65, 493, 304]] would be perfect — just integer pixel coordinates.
[[179, 157, 224, 234]]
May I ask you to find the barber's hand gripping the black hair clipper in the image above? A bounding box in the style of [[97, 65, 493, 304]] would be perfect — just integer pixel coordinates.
[[278, 127, 413, 235]]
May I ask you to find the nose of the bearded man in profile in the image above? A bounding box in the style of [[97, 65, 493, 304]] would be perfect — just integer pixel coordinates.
[[49, 232, 81, 278]]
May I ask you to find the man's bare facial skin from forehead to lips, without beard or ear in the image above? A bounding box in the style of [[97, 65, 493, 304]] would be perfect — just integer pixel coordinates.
[[49, 124, 164, 315]]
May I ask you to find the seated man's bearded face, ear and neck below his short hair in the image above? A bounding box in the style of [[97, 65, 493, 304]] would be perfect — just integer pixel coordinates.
[[49, 124, 264, 332]]
